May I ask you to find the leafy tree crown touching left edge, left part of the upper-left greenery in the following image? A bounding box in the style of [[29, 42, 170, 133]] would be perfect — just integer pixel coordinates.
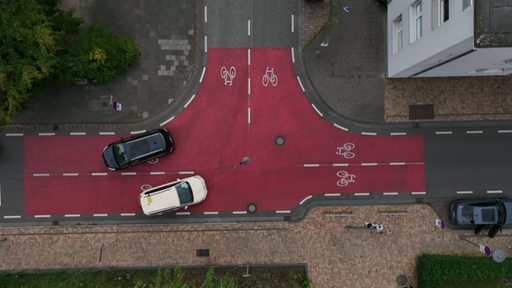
[[0, 0, 59, 123]]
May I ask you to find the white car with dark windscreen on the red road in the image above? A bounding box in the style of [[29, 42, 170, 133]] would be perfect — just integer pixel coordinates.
[[140, 175, 208, 215]]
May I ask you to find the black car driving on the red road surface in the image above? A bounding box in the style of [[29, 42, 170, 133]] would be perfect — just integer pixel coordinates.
[[103, 128, 174, 170]]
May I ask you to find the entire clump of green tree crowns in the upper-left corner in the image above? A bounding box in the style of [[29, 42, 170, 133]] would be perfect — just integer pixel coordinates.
[[0, 0, 140, 123]]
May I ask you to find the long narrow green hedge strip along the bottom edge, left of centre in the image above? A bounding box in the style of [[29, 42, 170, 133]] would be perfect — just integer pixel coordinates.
[[0, 267, 304, 288]]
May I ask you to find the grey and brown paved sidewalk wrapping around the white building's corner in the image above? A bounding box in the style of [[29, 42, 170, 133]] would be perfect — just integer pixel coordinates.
[[303, 0, 512, 123]]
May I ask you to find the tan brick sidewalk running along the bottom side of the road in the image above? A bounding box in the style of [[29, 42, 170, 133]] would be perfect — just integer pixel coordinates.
[[0, 205, 512, 288]]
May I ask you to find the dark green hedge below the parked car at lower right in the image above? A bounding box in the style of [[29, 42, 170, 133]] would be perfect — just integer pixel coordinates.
[[417, 254, 512, 288]]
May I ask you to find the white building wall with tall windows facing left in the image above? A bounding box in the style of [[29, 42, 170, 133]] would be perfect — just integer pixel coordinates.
[[387, 0, 474, 78]]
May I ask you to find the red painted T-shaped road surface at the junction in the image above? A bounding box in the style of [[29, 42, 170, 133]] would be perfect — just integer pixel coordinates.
[[25, 49, 425, 215]]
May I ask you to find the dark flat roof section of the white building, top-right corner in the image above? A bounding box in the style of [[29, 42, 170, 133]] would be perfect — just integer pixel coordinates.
[[474, 0, 512, 48]]
